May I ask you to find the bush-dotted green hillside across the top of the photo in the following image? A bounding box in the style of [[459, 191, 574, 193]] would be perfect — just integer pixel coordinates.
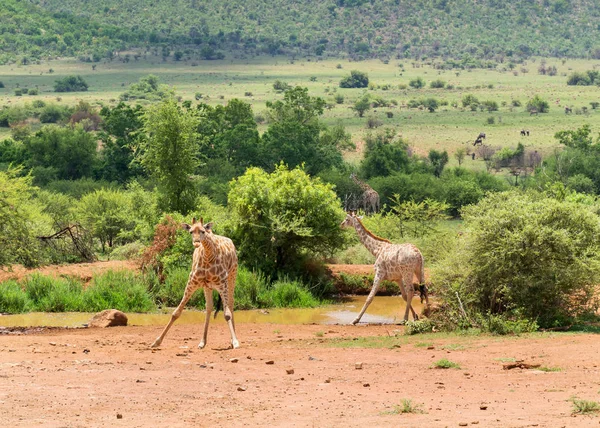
[[0, 0, 600, 66]]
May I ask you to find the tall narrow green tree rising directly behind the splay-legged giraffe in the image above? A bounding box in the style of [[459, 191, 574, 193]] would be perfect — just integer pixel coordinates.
[[140, 99, 199, 214]]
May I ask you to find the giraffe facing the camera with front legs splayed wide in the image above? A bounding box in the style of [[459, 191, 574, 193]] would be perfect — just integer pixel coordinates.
[[151, 218, 240, 349]]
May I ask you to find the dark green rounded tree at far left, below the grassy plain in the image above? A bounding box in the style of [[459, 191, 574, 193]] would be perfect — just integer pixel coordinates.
[[25, 125, 97, 180]]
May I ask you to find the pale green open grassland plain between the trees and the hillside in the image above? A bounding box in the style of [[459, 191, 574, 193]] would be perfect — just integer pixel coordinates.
[[0, 54, 600, 164]]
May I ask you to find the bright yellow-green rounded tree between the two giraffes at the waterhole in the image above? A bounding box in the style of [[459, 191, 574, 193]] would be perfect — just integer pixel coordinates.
[[229, 165, 344, 276]]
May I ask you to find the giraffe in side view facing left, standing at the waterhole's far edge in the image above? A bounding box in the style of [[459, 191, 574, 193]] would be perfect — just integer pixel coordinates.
[[341, 212, 429, 324]]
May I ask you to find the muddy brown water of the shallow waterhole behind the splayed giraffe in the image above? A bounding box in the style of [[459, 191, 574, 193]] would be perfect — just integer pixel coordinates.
[[0, 296, 422, 327]]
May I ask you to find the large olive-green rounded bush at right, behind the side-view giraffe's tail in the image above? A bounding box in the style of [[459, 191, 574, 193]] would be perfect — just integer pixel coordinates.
[[434, 192, 600, 327]]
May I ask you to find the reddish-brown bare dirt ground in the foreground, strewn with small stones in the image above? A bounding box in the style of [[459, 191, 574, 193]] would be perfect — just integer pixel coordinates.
[[0, 260, 600, 427]]
